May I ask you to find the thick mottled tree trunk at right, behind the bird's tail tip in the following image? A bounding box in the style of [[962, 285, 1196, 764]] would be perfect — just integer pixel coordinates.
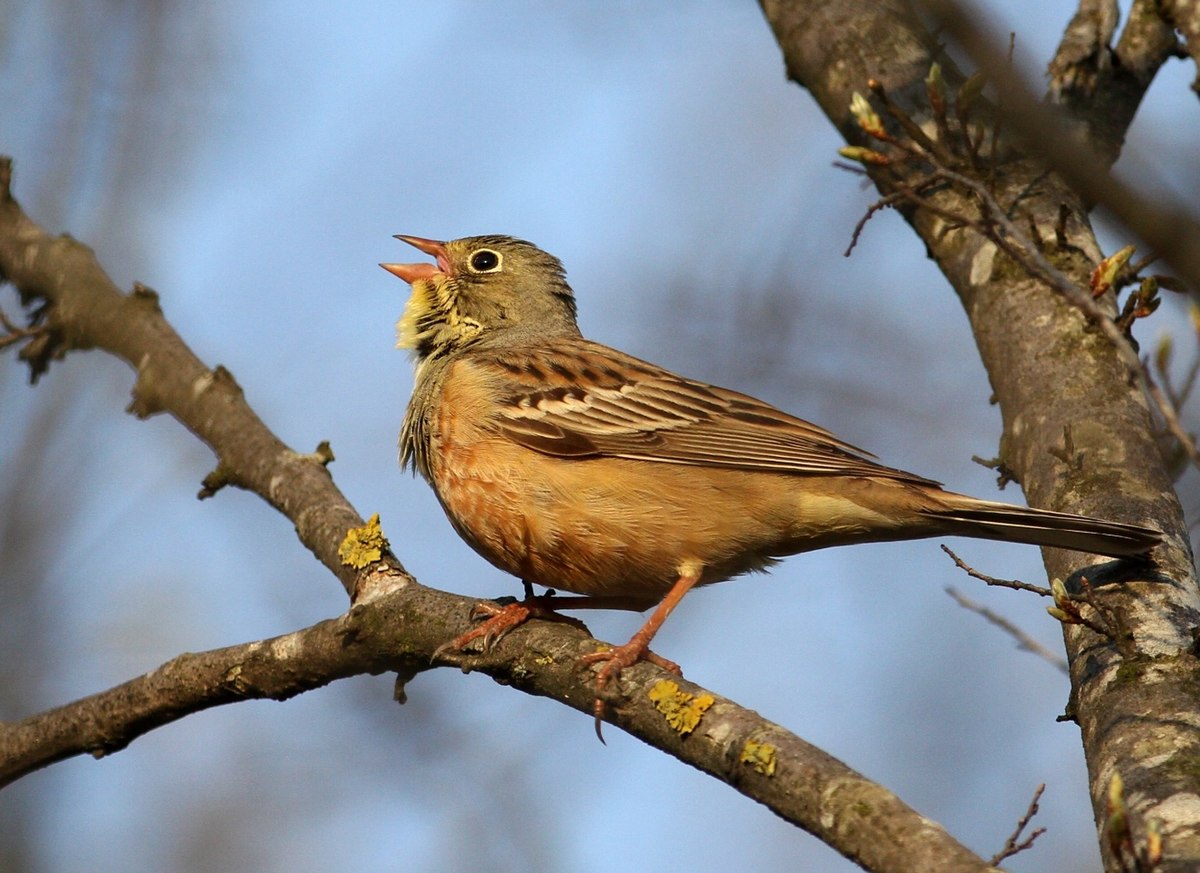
[[763, 0, 1200, 871]]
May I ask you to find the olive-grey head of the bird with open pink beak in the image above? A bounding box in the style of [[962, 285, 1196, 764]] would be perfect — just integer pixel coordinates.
[[379, 235, 580, 360]]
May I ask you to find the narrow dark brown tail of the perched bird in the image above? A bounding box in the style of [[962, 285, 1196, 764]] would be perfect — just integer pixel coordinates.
[[935, 495, 1163, 558]]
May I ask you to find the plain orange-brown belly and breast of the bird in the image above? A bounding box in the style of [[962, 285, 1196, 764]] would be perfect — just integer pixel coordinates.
[[422, 438, 902, 600]]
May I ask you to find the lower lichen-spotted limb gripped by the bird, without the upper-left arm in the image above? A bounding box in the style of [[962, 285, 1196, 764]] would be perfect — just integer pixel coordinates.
[[0, 571, 991, 873]]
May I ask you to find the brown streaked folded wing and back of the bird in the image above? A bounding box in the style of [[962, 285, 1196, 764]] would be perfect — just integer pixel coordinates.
[[476, 339, 937, 484]]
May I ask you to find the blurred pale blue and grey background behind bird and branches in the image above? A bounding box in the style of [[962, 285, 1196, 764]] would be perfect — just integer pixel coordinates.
[[0, 0, 1200, 873]]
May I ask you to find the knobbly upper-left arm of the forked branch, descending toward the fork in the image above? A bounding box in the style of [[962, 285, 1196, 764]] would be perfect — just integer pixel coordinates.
[[0, 158, 381, 592]]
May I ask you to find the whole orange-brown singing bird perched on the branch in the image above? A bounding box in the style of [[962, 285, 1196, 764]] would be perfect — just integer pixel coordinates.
[[380, 235, 1162, 740]]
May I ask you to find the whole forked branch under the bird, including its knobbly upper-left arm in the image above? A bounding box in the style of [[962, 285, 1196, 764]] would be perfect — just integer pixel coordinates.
[[0, 158, 990, 873]]
